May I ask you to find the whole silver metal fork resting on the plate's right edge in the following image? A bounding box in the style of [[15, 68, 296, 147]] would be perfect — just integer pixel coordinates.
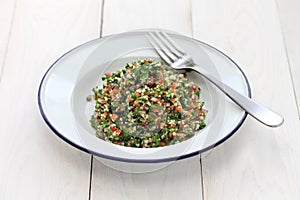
[[146, 32, 284, 127]]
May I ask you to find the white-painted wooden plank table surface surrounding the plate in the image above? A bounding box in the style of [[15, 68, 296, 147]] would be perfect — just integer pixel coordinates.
[[0, 0, 300, 200]]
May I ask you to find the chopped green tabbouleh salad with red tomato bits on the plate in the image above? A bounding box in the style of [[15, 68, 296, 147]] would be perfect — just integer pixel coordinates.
[[90, 59, 206, 148]]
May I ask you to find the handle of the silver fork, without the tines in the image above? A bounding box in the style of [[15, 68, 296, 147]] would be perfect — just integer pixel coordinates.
[[189, 66, 284, 127]]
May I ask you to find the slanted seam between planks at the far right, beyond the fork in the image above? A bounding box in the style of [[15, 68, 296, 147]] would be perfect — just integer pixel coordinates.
[[275, 0, 300, 120]]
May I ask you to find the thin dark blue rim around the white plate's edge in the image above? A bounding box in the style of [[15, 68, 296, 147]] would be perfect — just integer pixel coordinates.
[[37, 30, 252, 163]]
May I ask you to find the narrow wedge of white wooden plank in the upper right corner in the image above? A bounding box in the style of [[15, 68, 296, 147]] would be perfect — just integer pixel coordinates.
[[277, 0, 300, 119]]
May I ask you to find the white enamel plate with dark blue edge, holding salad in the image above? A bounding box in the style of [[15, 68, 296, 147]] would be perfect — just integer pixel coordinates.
[[38, 31, 250, 163]]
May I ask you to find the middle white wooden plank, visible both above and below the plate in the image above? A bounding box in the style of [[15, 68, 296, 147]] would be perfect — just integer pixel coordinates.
[[91, 0, 202, 199]]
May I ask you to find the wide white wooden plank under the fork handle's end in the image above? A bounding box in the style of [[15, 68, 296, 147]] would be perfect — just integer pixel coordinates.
[[192, 0, 300, 199]]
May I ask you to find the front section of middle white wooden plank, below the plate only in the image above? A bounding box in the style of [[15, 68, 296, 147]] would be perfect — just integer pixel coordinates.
[[91, 156, 202, 200]]
